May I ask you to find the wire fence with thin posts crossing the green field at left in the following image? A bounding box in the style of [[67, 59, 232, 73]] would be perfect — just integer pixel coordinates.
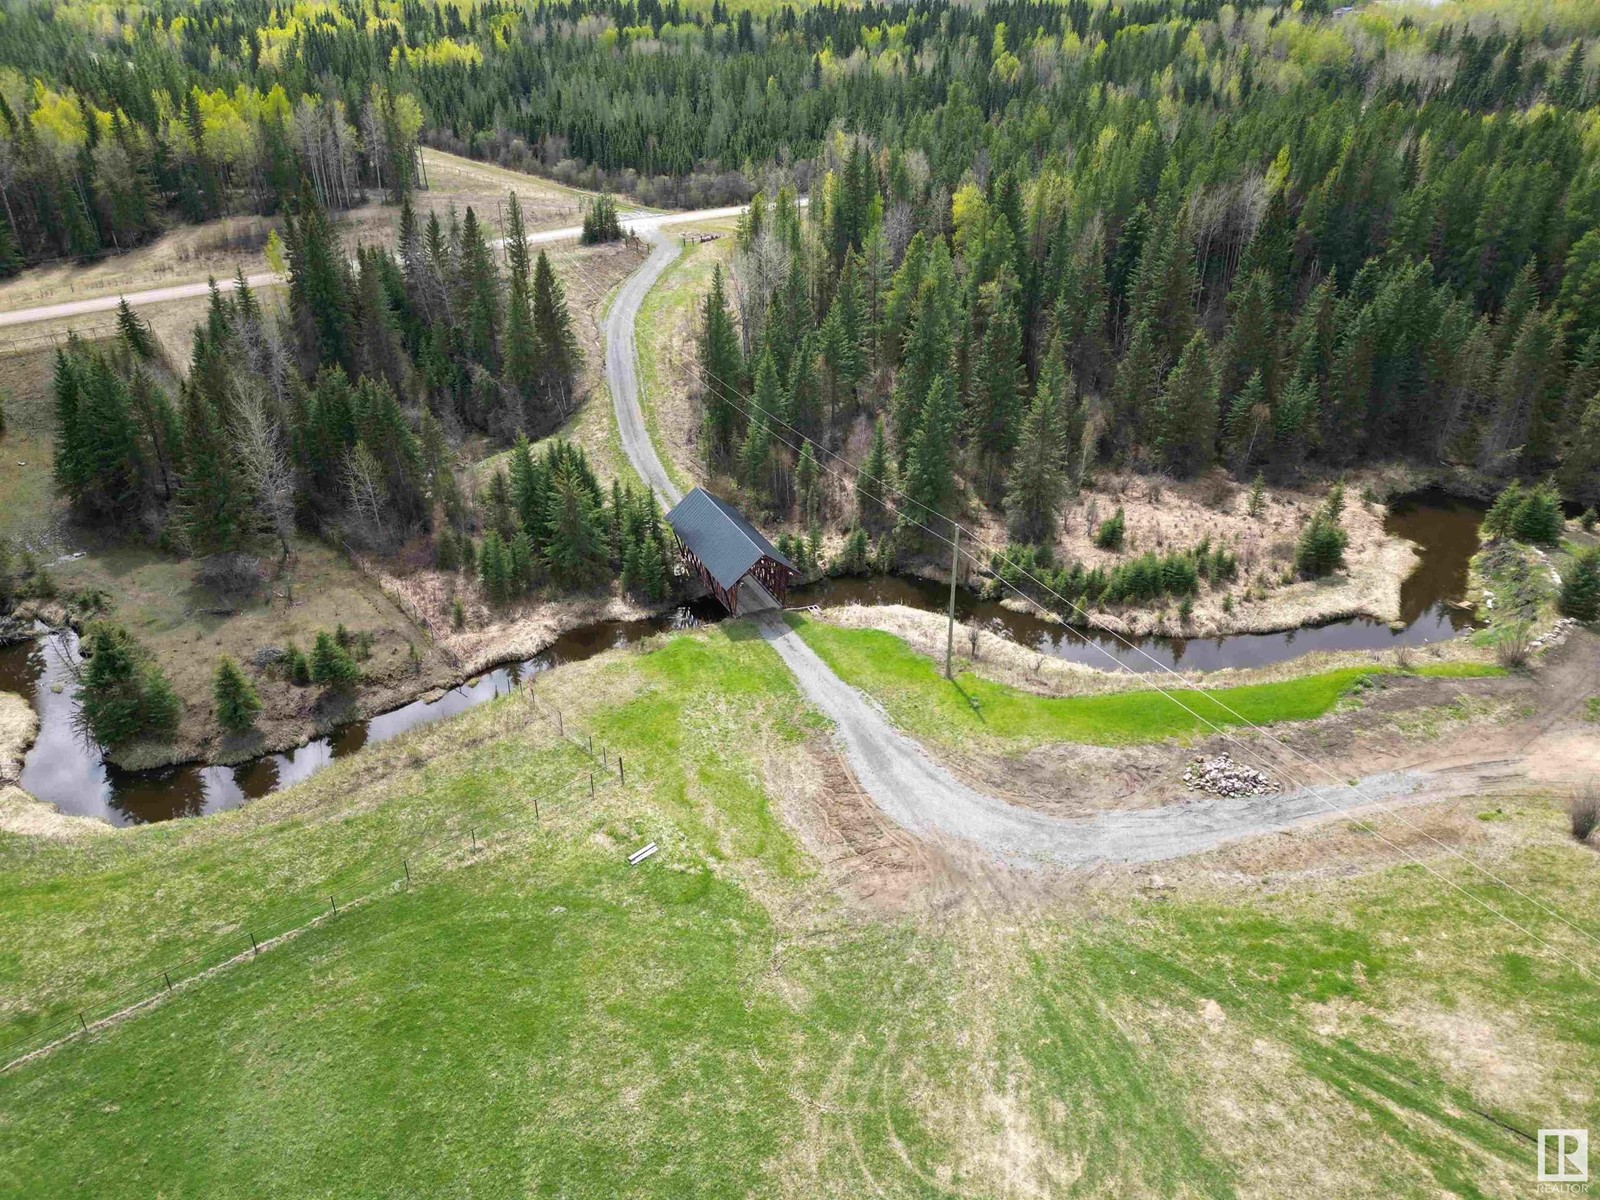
[[0, 683, 627, 1072]]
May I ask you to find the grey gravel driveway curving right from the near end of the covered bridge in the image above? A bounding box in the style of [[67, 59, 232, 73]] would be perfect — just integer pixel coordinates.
[[760, 616, 1426, 867]]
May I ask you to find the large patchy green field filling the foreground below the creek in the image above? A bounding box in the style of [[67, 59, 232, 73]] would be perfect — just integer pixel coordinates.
[[0, 624, 1600, 1197]]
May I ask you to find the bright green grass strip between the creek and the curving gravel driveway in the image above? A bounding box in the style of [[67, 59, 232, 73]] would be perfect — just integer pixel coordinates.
[[789, 614, 1499, 746]]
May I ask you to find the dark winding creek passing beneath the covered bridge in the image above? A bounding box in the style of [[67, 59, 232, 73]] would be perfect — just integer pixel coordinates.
[[0, 493, 1483, 826]]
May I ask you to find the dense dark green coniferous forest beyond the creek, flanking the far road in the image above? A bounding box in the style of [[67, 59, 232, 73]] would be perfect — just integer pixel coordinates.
[[0, 0, 1600, 601]]
